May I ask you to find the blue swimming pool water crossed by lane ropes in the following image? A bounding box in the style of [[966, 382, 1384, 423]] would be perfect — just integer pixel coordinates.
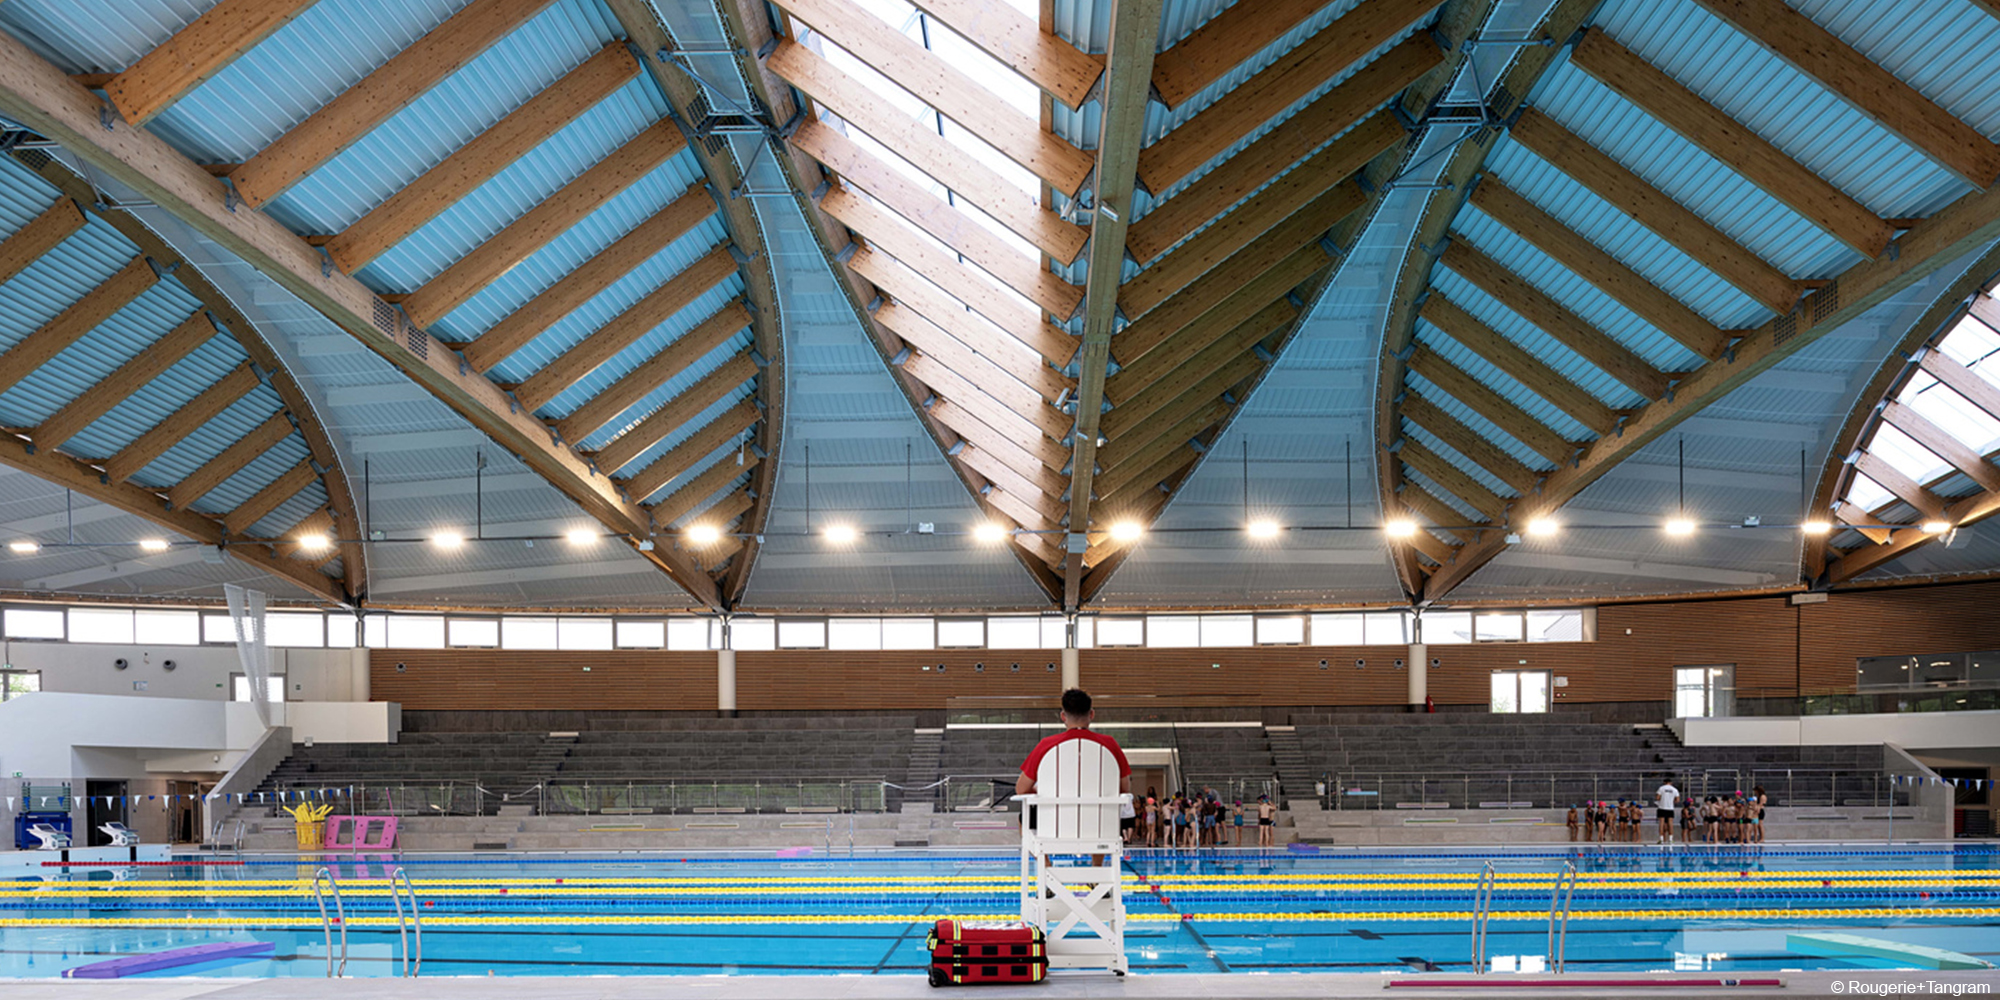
[[0, 846, 2000, 978]]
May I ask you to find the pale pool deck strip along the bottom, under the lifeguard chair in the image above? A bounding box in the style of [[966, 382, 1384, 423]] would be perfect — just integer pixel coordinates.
[[11, 970, 2000, 1000]]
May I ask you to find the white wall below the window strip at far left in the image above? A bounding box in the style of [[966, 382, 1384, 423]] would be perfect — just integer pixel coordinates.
[[0, 640, 368, 702]]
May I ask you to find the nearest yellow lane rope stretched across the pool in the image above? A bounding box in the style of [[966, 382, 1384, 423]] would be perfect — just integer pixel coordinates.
[[0, 906, 2000, 930]]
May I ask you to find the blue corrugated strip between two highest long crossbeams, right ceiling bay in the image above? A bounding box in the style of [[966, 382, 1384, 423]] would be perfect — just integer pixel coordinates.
[[1596, 0, 1968, 218]]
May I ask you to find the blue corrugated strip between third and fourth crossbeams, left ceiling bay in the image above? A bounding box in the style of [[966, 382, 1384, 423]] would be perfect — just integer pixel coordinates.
[[356, 84, 688, 290]]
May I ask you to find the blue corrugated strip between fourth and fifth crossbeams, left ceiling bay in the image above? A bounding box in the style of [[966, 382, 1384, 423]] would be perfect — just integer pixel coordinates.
[[404, 154, 698, 340]]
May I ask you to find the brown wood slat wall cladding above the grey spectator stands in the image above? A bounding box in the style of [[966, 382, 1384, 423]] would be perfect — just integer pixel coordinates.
[[370, 582, 2000, 712]]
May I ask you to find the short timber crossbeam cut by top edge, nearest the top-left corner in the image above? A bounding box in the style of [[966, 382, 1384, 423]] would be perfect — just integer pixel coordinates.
[[104, 0, 318, 128]]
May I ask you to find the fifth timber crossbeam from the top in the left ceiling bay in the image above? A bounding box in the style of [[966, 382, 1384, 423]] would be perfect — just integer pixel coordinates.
[[464, 184, 716, 372]]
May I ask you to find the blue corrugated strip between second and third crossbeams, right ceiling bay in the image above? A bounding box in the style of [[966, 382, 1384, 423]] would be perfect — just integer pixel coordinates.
[[1538, 62, 1862, 278]]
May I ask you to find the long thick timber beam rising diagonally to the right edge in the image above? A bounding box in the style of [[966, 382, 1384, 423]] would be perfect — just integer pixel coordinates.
[[1424, 149, 2000, 600]]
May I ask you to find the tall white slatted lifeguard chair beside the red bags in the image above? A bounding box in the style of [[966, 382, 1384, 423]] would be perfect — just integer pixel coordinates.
[[1014, 740, 1130, 976]]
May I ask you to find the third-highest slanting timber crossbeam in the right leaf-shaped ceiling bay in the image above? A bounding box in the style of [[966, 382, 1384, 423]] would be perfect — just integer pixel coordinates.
[[1508, 108, 1800, 316]]
